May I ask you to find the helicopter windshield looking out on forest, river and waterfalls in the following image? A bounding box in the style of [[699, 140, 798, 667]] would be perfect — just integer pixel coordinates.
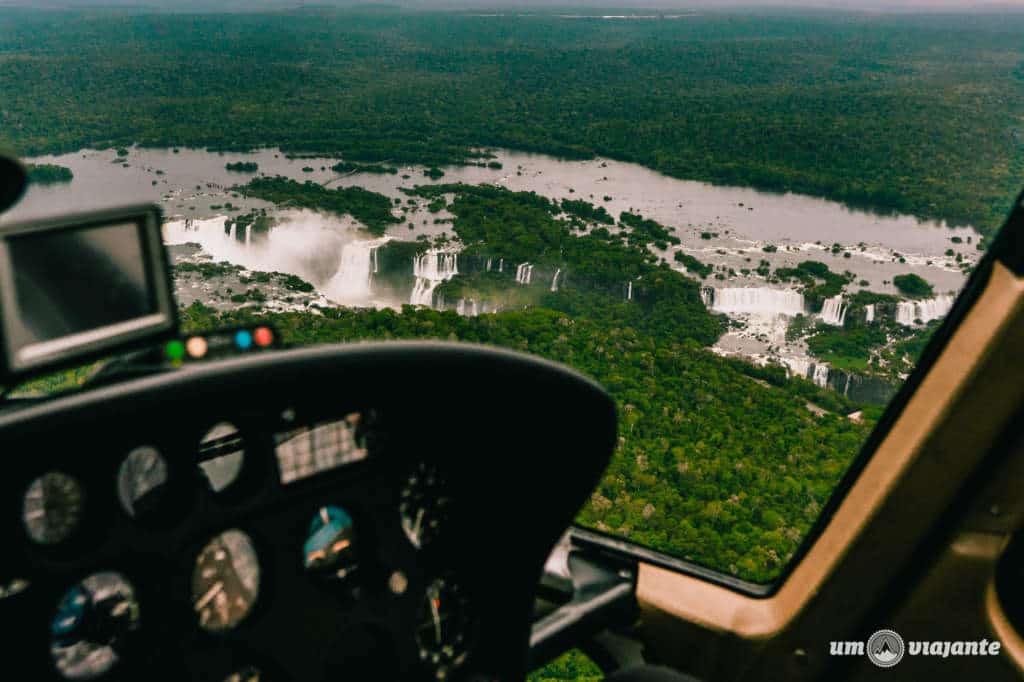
[[0, 0, 1024, 583]]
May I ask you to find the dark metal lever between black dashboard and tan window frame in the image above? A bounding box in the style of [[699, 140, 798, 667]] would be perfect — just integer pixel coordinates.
[[529, 549, 637, 669]]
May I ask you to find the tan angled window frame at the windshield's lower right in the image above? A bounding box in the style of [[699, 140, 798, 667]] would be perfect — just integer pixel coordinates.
[[637, 262, 1024, 667]]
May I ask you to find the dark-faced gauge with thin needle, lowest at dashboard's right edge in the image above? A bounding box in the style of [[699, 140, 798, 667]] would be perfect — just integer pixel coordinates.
[[416, 579, 471, 680]]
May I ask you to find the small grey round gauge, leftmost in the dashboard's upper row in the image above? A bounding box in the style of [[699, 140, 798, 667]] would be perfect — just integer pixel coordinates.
[[23, 471, 84, 545]]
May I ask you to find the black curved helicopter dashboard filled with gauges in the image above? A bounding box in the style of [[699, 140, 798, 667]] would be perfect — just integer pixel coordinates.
[[0, 343, 616, 681]]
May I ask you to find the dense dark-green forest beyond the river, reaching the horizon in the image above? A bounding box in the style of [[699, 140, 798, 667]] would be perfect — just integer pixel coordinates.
[[0, 7, 1024, 235]]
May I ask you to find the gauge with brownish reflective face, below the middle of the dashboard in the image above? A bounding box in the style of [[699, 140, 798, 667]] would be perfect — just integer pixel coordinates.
[[193, 530, 259, 632]]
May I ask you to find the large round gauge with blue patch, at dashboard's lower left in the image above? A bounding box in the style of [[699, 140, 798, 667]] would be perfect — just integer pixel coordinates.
[[50, 572, 139, 680]]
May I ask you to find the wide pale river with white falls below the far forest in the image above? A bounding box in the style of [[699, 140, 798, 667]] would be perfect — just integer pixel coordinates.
[[0, 148, 980, 391]]
